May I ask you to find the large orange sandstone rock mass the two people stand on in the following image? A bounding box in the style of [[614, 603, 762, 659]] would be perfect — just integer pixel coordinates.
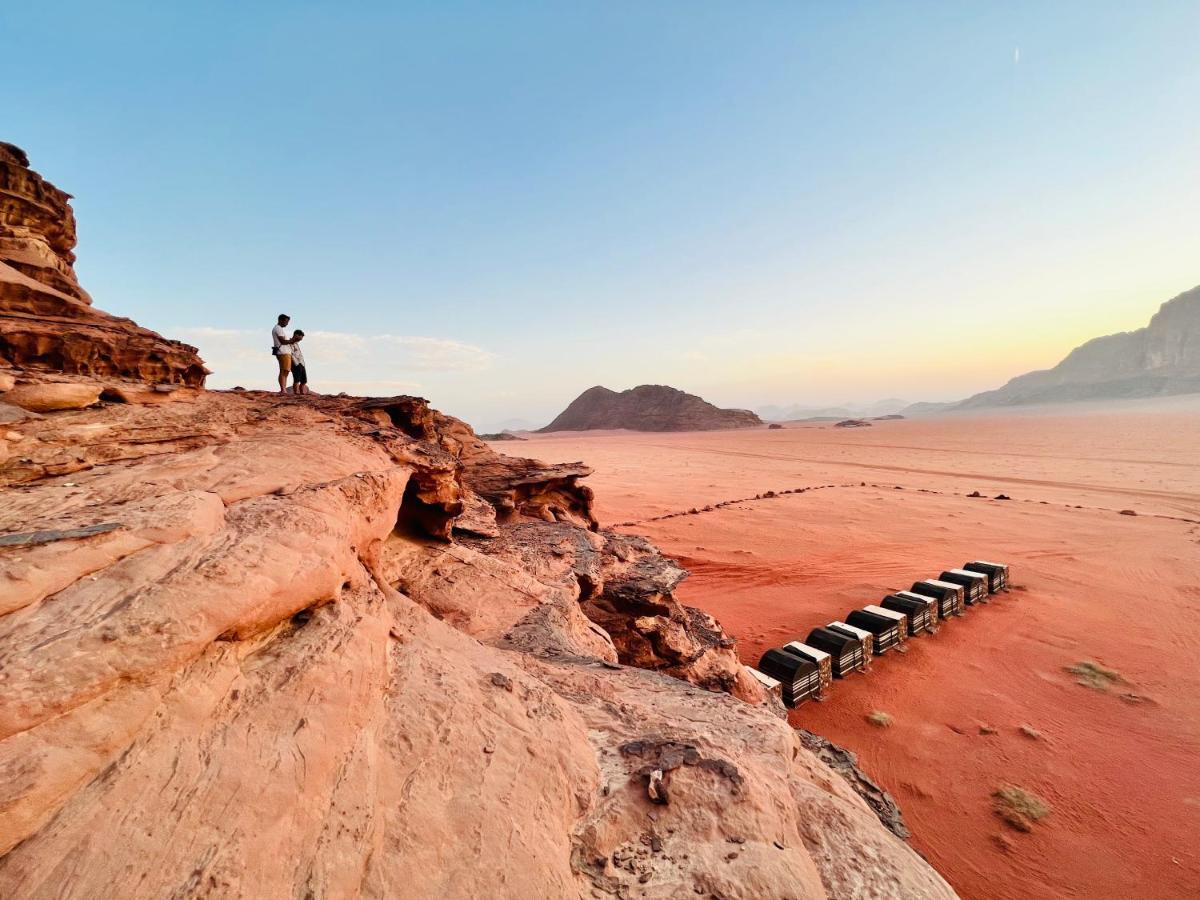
[[0, 144, 953, 900]]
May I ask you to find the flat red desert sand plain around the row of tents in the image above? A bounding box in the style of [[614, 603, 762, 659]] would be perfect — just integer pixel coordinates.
[[518, 412, 1200, 899]]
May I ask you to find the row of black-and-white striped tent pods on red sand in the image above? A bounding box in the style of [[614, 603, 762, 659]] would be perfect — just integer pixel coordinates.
[[748, 559, 1009, 707]]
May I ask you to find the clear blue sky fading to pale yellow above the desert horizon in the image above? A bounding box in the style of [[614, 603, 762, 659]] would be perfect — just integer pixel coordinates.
[[0, 0, 1200, 427]]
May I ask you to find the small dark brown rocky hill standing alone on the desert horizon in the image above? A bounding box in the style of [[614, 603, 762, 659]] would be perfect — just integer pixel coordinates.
[[541, 384, 762, 432]]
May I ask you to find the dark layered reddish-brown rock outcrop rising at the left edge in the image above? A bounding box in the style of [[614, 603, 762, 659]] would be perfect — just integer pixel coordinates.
[[0, 143, 206, 386]]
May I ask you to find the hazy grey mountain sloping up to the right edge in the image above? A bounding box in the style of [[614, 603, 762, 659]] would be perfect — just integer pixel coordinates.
[[904, 287, 1200, 415]]
